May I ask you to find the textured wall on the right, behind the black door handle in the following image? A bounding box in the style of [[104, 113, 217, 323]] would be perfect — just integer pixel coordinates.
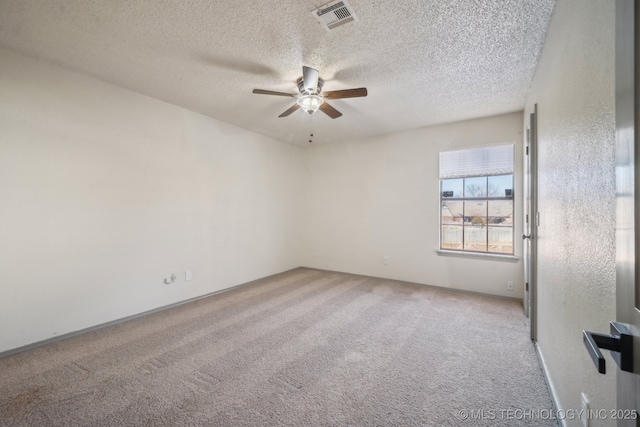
[[526, 0, 616, 426]]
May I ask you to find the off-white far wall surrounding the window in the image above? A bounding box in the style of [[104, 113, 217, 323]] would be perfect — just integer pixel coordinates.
[[302, 112, 523, 298]]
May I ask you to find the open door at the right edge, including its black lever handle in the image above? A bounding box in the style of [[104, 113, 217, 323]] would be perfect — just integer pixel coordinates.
[[583, 0, 640, 426]]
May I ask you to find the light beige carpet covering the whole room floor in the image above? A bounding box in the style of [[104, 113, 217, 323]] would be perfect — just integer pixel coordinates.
[[0, 268, 555, 426]]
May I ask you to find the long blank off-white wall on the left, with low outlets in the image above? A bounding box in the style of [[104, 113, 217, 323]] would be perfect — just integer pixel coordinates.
[[0, 50, 302, 352]]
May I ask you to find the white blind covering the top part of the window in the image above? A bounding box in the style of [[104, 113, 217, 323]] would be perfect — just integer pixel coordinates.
[[440, 144, 513, 179]]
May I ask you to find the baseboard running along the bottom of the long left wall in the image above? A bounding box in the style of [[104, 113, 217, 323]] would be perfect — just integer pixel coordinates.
[[0, 267, 300, 359]]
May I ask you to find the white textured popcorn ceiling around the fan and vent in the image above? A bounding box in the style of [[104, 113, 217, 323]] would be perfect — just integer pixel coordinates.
[[0, 0, 554, 145]]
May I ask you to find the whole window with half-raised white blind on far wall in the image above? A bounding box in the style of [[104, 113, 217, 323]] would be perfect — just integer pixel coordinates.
[[440, 144, 514, 255]]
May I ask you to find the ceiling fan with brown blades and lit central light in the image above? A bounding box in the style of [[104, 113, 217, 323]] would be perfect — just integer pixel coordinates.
[[253, 66, 367, 119]]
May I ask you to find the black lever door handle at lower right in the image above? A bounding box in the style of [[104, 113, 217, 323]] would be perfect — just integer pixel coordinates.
[[582, 322, 633, 374]]
